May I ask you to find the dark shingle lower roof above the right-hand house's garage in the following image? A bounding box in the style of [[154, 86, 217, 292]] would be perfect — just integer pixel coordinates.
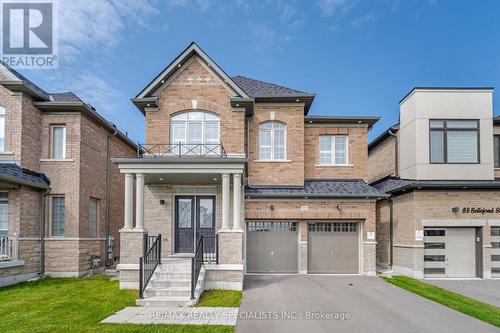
[[371, 177, 500, 194]]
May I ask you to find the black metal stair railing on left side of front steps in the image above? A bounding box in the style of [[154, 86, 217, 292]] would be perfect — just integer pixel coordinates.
[[139, 234, 161, 298]]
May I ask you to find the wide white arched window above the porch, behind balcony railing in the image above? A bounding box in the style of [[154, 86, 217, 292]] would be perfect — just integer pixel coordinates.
[[170, 111, 220, 154]]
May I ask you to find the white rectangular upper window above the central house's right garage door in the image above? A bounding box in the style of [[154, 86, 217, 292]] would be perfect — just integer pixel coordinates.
[[319, 135, 349, 165]]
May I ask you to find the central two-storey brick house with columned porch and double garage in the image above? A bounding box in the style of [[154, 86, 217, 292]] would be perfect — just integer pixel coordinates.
[[114, 43, 386, 305]]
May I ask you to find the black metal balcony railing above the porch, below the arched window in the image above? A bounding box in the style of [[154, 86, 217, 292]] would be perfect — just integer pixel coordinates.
[[137, 143, 227, 158]]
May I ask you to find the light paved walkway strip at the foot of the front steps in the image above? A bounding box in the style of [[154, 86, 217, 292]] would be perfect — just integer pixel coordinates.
[[101, 307, 239, 326]]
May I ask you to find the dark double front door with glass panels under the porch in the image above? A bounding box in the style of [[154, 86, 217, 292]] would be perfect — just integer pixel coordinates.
[[175, 196, 215, 253]]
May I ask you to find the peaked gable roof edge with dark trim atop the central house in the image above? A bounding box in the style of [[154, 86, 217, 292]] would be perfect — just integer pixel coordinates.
[[132, 42, 249, 101]]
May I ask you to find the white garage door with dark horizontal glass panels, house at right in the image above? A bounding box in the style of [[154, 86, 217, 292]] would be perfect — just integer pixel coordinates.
[[424, 228, 476, 278]]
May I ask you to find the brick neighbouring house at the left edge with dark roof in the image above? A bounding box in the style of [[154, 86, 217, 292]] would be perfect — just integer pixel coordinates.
[[0, 65, 137, 285]]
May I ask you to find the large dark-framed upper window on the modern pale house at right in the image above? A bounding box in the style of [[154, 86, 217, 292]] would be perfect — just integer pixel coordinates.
[[430, 120, 479, 164]]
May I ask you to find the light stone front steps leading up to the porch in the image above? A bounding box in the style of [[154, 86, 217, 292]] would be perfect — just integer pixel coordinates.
[[136, 258, 205, 307]]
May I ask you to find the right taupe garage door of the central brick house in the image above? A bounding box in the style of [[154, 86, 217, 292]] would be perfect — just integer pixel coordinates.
[[307, 222, 359, 274]]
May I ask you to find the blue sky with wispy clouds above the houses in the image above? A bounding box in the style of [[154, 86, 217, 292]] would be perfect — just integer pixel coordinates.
[[17, 0, 500, 143]]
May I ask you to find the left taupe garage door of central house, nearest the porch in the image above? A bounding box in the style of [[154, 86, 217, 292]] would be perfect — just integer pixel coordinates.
[[246, 221, 298, 273]]
